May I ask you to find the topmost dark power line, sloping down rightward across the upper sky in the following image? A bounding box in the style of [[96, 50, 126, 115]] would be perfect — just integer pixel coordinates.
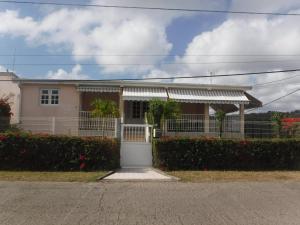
[[0, 0, 300, 16]]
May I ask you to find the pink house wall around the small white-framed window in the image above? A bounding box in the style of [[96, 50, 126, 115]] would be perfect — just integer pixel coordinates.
[[21, 84, 80, 135]]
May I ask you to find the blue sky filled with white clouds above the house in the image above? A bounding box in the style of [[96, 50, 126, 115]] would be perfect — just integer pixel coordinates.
[[0, 0, 300, 112]]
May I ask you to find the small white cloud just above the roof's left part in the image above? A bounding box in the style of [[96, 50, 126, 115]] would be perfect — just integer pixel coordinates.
[[47, 65, 89, 80]]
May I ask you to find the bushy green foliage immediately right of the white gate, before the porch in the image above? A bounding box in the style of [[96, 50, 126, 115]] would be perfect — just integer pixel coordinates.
[[147, 99, 180, 128]]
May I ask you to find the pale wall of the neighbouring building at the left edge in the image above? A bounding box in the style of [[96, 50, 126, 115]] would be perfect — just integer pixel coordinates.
[[0, 72, 20, 124]]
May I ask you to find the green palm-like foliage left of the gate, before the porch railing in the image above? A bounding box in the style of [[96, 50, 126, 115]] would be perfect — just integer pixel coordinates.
[[91, 99, 119, 118]]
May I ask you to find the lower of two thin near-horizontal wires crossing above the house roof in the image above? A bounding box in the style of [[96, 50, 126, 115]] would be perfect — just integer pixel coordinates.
[[0, 59, 300, 66]]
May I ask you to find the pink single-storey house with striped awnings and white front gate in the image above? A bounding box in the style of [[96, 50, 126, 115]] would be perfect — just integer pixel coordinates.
[[1, 74, 262, 167]]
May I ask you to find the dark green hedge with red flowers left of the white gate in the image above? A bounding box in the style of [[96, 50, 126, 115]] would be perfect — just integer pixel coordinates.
[[0, 133, 120, 171]]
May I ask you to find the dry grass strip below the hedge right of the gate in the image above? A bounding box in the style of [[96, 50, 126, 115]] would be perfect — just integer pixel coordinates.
[[167, 171, 300, 182]]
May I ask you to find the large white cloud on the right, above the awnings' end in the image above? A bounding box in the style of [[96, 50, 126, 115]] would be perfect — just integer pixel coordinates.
[[148, 1, 300, 111]]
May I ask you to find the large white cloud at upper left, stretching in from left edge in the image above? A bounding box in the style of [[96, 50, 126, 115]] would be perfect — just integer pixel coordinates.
[[0, 0, 225, 73]]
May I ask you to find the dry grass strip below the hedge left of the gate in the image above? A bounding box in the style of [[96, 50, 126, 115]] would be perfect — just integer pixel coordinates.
[[0, 171, 107, 182]]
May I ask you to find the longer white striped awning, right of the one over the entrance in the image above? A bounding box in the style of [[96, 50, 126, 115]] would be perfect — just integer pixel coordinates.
[[168, 88, 249, 104]]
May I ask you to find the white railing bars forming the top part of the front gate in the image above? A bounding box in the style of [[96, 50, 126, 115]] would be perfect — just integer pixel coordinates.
[[121, 124, 152, 143]]
